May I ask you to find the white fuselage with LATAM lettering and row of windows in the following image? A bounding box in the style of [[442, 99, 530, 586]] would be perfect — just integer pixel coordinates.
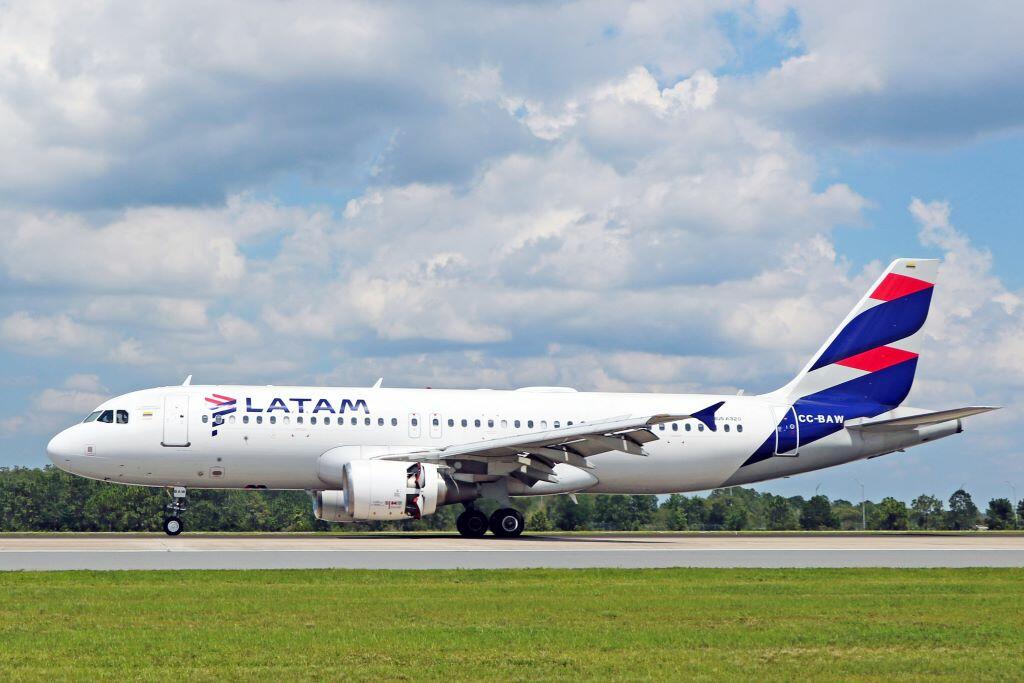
[[47, 386, 959, 495]]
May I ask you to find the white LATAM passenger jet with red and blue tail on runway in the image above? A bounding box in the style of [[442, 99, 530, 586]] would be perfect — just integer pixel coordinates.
[[46, 258, 996, 538]]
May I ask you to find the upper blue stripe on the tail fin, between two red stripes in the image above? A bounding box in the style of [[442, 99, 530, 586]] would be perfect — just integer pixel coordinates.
[[811, 287, 933, 370]]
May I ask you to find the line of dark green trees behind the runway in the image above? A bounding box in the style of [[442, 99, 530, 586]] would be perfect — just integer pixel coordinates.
[[0, 467, 1024, 531]]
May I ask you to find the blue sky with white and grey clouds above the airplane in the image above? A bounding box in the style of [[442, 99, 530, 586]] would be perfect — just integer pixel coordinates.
[[0, 0, 1024, 502]]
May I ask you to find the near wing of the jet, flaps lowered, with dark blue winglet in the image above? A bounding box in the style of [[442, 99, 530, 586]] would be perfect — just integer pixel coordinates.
[[383, 401, 722, 485]]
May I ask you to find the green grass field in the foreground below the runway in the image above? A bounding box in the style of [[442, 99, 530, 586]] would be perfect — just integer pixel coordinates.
[[0, 569, 1024, 681]]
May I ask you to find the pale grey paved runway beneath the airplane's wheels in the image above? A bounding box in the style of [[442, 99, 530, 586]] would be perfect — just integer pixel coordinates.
[[0, 533, 1024, 570]]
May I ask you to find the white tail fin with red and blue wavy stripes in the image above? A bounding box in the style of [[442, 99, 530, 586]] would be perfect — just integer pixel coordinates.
[[777, 258, 939, 417]]
